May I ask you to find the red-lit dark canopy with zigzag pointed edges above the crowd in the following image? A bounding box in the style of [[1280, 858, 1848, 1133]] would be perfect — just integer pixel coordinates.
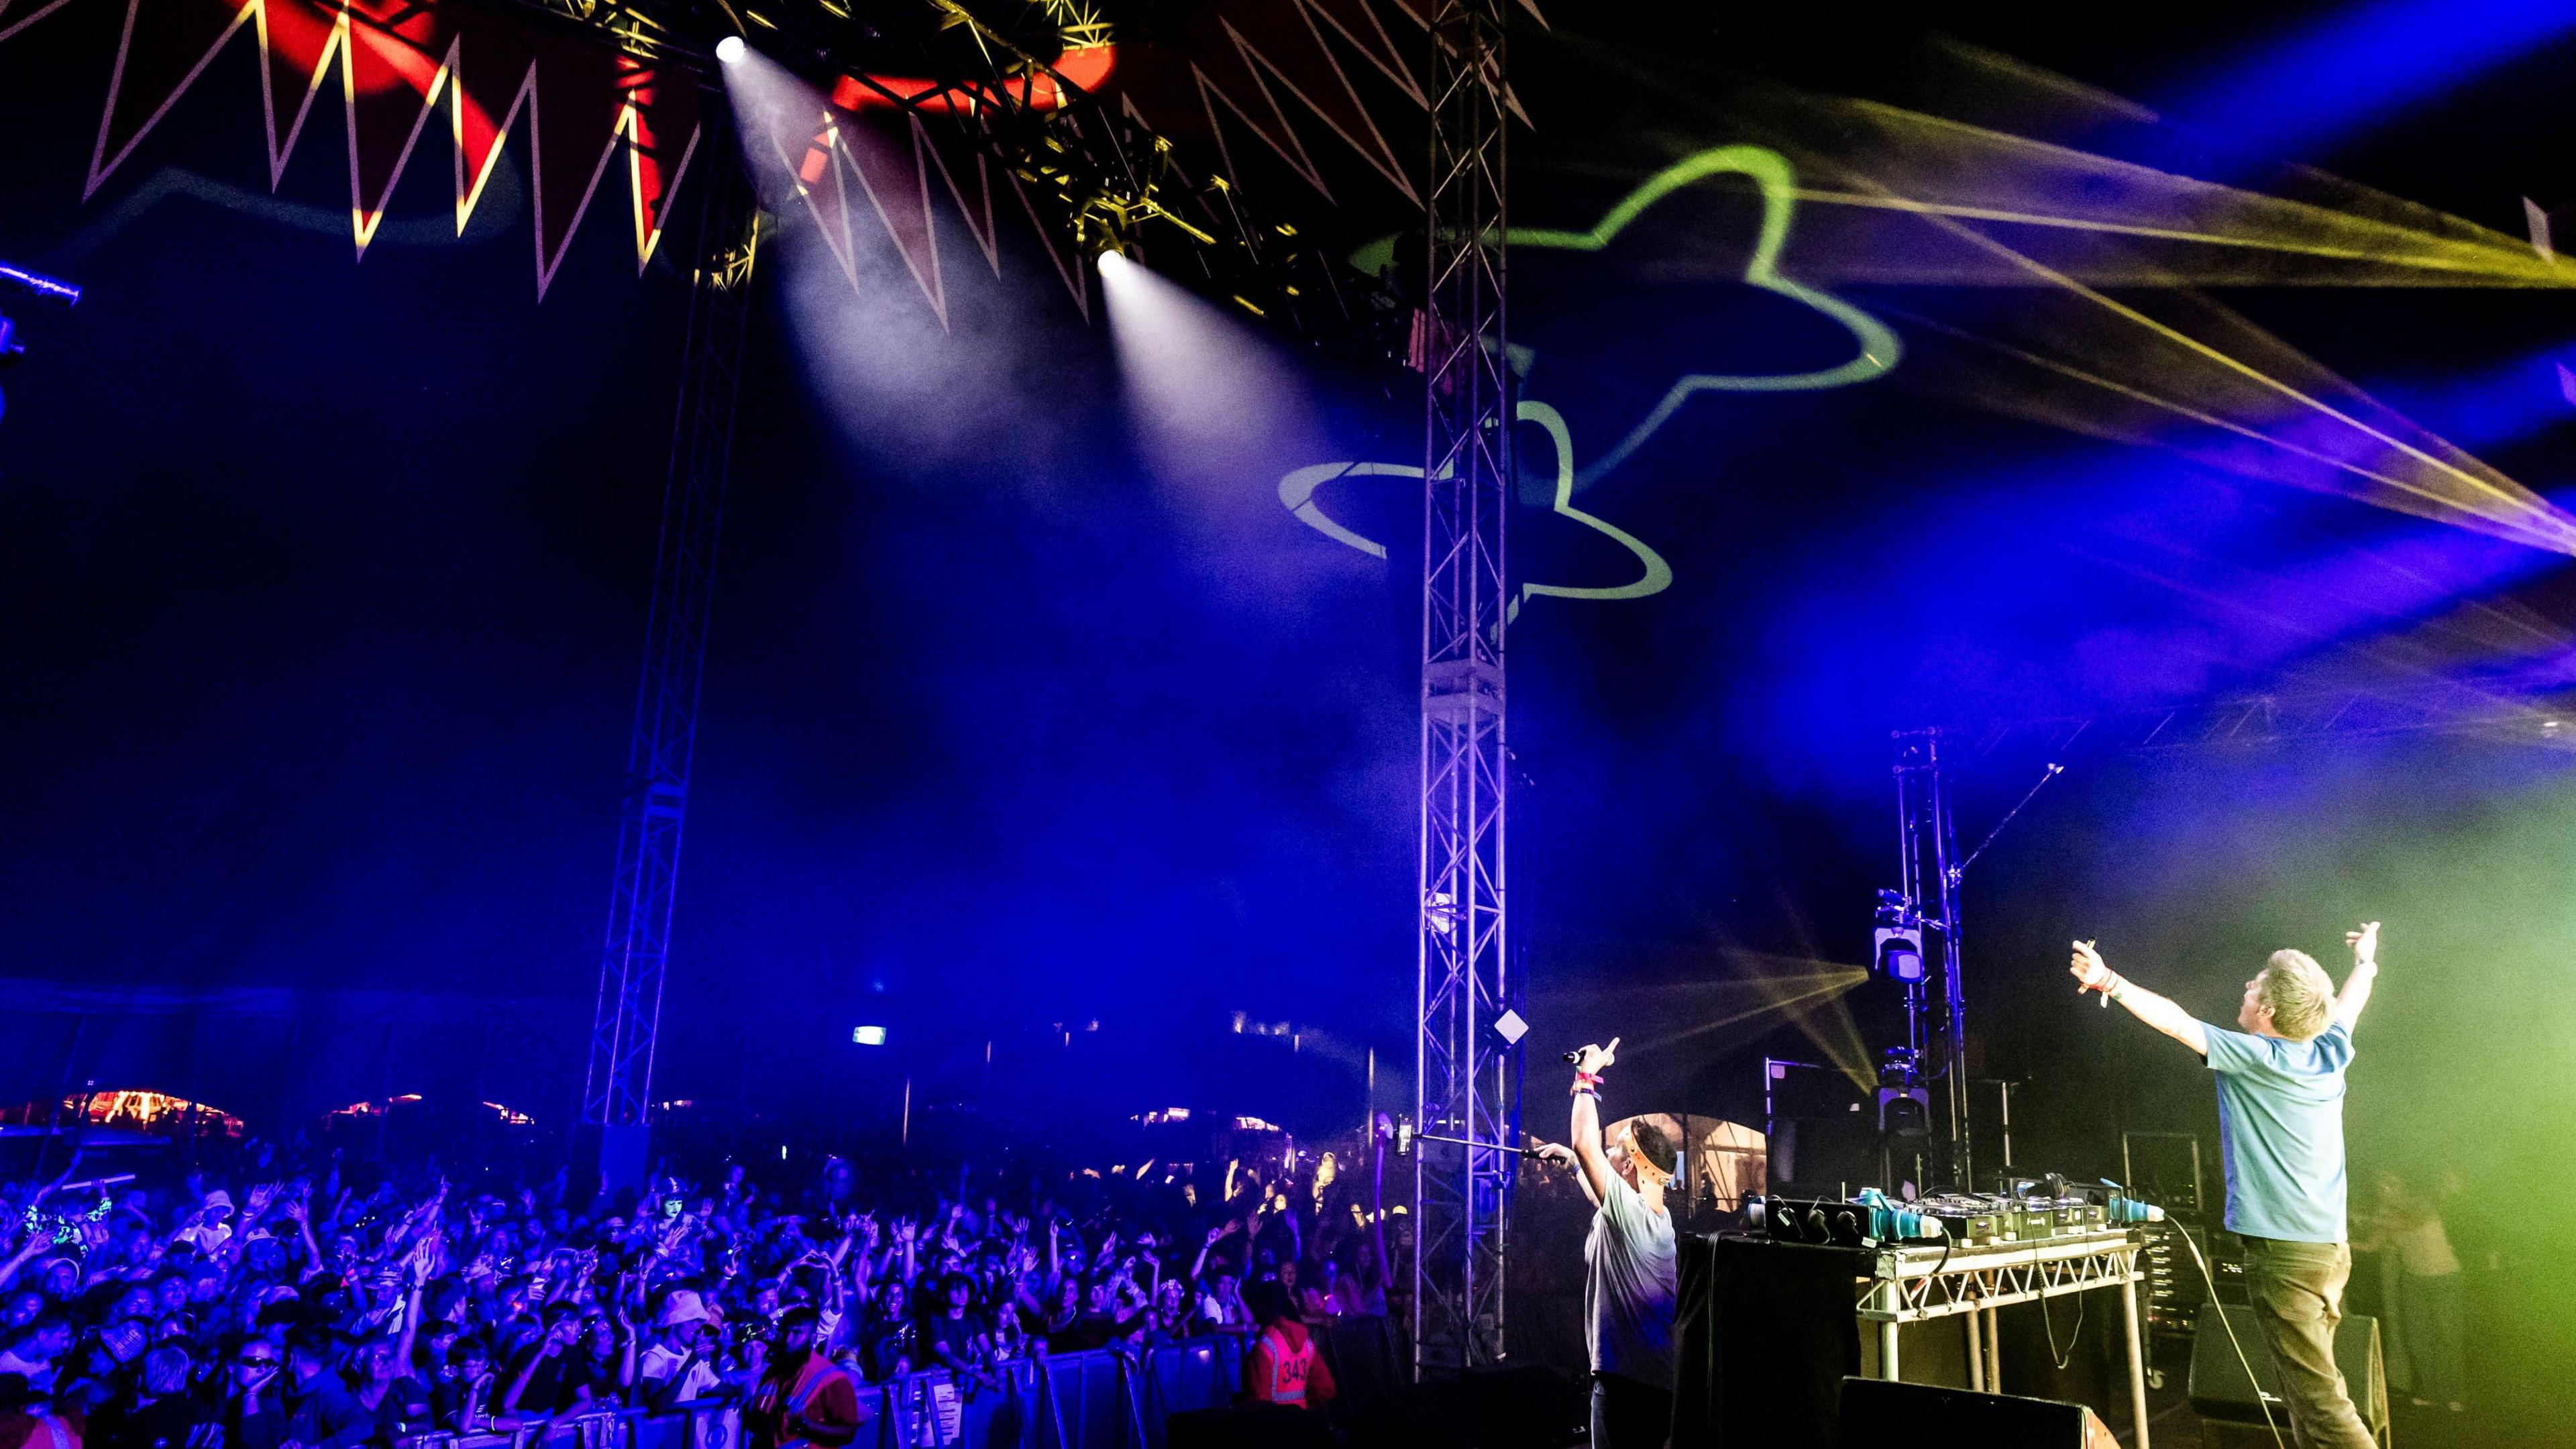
[[0, 0, 1473, 301]]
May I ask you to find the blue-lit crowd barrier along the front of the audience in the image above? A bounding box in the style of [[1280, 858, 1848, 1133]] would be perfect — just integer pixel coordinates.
[[396, 1320, 1288, 1449]]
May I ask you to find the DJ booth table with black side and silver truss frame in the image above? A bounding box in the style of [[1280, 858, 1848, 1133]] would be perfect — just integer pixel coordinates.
[[1672, 1227, 2149, 1449]]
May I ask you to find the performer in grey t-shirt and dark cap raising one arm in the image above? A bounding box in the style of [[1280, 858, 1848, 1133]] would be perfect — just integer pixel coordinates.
[[1536, 1036, 1674, 1449]]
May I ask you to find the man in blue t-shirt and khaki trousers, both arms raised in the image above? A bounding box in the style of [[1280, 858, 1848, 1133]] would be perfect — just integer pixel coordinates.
[[2069, 920, 2380, 1449]]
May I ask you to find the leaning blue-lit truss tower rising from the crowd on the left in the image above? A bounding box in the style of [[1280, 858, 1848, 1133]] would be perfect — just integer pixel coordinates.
[[582, 123, 760, 1129]]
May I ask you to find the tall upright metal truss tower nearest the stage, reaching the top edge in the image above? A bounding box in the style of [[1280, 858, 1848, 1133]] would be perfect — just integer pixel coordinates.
[[1411, 0, 1520, 1377]]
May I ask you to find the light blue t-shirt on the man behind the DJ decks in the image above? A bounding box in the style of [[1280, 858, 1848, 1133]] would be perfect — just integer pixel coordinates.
[[2202, 1021, 2352, 1243]]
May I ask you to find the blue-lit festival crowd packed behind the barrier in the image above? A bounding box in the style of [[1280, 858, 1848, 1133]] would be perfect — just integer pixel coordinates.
[[0, 1142, 1401, 1449]]
